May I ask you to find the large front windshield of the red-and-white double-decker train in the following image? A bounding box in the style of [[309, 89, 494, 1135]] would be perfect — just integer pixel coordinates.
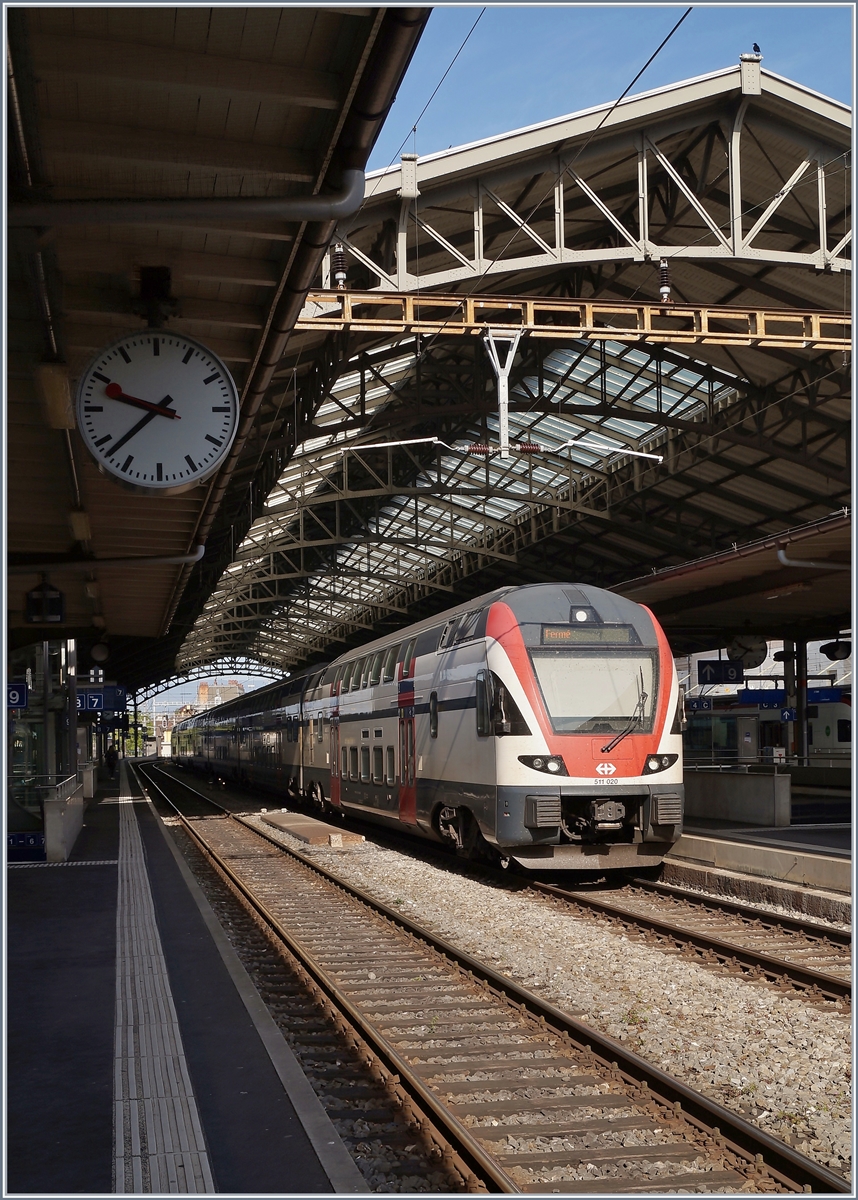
[[530, 649, 658, 733]]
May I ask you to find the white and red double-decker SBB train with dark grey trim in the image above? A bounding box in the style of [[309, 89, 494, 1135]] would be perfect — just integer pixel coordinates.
[[173, 584, 684, 870]]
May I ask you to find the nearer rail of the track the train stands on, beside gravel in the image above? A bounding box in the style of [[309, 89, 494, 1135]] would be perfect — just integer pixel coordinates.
[[529, 880, 852, 1002]]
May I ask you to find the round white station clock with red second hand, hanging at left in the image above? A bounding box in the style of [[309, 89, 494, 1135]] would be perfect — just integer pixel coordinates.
[[77, 329, 239, 496]]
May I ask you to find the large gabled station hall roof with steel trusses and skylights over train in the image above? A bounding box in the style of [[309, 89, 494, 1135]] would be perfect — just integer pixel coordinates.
[[8, 42, 852, 685]]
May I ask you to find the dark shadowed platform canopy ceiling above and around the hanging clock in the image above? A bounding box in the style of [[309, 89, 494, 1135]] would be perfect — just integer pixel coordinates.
[[6, 5, 430, 686]]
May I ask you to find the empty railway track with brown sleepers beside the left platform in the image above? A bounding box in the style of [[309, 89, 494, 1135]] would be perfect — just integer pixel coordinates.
[[134, 770, 850, 1194]]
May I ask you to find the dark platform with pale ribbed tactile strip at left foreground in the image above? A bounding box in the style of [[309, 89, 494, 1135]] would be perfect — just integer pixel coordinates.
[[7, 763, 367, 1195]]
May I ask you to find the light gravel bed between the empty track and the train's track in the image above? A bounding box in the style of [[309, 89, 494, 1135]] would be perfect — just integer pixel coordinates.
[[250, 817, 852, 1175]]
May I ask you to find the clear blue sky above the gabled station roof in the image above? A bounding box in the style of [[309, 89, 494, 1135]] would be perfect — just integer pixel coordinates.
[[368, 2, 854, 170]]
